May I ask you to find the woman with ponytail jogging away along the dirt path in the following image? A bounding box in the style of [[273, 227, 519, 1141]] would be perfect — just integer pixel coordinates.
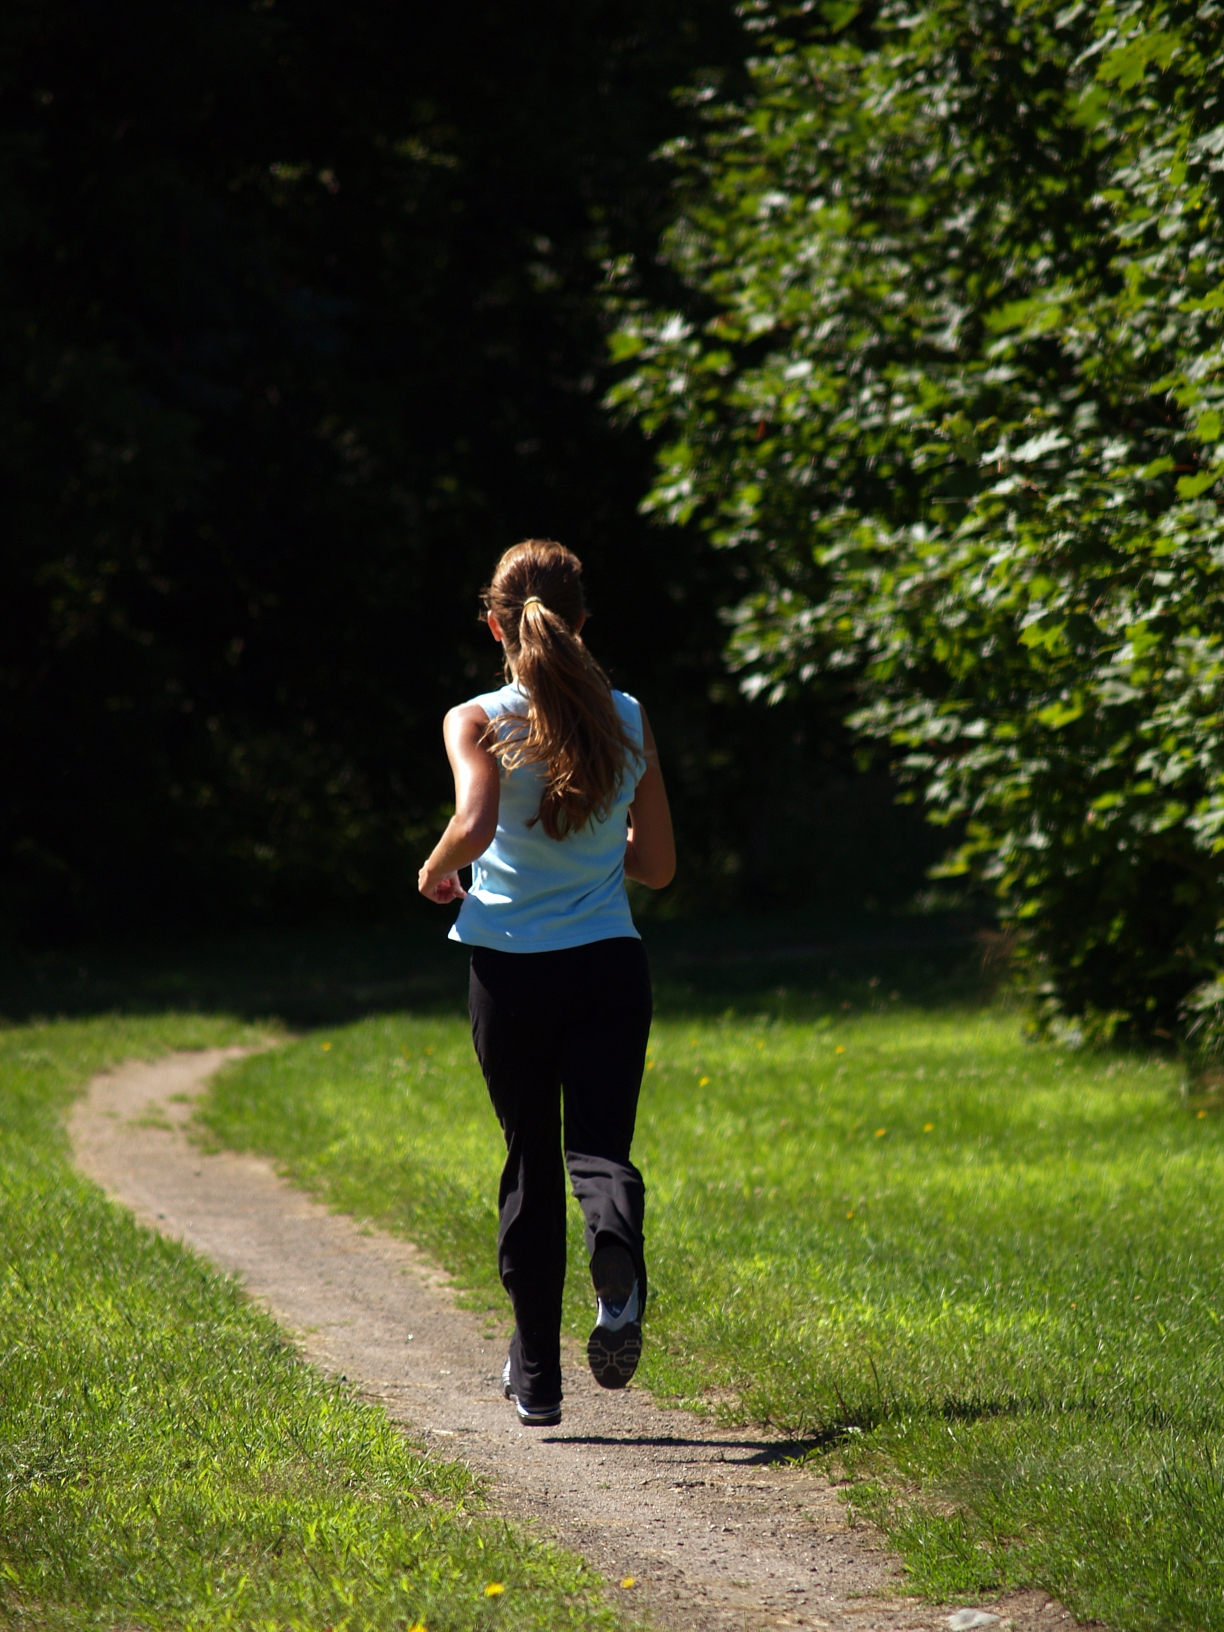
[[419, 539, 676, 1426]]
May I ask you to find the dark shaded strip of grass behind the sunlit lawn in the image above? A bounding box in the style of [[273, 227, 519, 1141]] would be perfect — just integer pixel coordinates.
[[0, 912, 989, 1030]]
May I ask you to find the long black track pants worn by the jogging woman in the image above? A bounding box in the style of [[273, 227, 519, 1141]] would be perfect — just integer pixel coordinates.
[[470, 937, 651, 1405]]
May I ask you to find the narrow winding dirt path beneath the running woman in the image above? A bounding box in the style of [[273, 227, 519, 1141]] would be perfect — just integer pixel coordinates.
[[70, 1049, 1071, 1632]]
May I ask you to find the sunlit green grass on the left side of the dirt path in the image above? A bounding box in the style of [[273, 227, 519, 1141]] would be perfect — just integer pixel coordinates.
[[0, 1015, 614, 1632]]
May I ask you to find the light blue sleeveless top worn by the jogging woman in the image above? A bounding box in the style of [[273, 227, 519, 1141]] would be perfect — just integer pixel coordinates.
[[450, 685, 646, 951]]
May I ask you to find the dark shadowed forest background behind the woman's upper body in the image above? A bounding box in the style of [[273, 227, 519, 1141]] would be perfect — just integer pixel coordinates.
[[0, 0, 943, 943]]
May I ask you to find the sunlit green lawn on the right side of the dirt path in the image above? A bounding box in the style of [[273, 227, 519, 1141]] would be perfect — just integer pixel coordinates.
[[206, 1004, 1224, 1629]]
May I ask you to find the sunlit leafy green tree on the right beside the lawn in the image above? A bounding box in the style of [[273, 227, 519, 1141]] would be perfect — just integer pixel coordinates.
[[614, 0, 1224, 1033]]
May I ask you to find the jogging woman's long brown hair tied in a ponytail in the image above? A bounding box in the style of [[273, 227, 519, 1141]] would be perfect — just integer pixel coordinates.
[[481, 539, 636, 839]]
